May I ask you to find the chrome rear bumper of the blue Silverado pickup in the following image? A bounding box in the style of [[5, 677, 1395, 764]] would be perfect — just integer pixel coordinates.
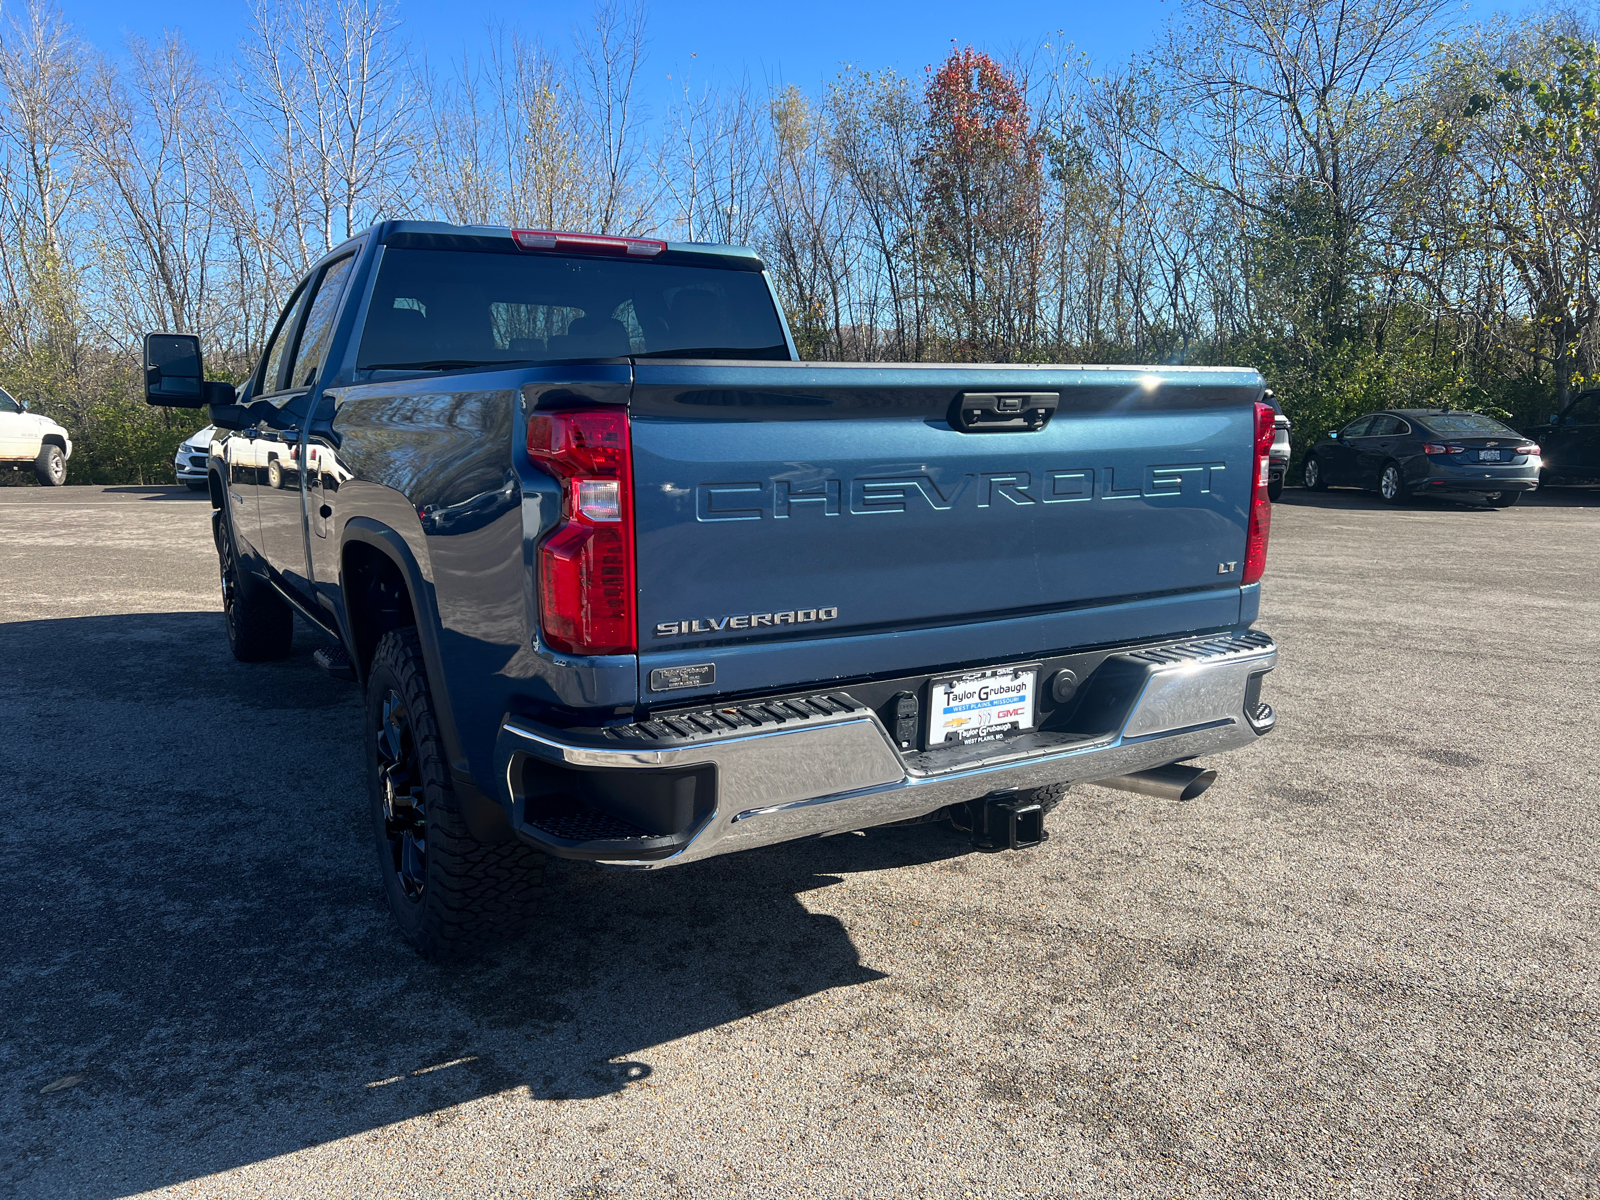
[[496, 630, 1277, 869]]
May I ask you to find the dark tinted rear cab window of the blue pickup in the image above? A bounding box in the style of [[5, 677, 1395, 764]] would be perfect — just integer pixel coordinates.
[[355, 238, 789, 371]]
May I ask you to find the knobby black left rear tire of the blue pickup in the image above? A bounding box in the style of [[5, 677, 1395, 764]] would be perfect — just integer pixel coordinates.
[[365, 629, 544, 958]]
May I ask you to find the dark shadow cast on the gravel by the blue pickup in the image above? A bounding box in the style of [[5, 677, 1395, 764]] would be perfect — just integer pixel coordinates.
[[0, 613, 968, 1197]]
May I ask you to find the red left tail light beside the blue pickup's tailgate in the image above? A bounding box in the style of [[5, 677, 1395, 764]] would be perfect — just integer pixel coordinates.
[[528, 408, 638, 654]]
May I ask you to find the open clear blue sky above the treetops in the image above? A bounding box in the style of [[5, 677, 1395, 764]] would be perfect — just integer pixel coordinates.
[[53, 0, 1523, 107]]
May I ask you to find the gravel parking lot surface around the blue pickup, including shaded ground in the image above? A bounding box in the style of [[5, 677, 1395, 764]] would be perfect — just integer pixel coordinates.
[[0, 486, 1600, 1200]]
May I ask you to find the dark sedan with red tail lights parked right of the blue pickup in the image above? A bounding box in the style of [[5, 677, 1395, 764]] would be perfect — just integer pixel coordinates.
[[1306, 408, 1539, 509]]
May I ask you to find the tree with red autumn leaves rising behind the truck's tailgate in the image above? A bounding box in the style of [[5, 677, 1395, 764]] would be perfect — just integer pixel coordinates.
[[917, 46, 1043, 360]]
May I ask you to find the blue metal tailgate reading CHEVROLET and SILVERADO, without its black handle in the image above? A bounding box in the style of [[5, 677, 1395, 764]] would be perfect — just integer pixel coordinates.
[[632, 362, 1261, 701]]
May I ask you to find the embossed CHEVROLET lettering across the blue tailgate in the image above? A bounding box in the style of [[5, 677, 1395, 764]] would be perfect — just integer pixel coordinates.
[[694, 462, 1227, 522]]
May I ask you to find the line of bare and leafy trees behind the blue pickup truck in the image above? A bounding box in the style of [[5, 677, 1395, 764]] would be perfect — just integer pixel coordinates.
[[0, 0, 1600, 483]]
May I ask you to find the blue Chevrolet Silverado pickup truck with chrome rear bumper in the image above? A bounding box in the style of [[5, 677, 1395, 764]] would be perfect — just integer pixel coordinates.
[[144, 221, 1277, 957]]
